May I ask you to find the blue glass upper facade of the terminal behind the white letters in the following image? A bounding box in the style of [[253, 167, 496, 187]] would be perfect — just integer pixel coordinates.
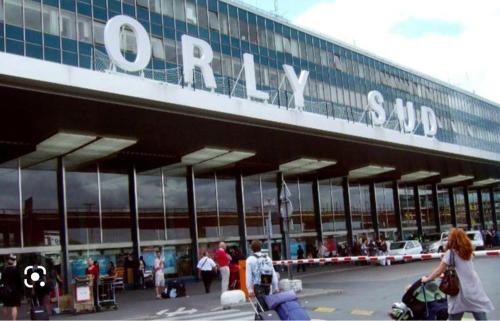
[[0, 0, 500, 153]]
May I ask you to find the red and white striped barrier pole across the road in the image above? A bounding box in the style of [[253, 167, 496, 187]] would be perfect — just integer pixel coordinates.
[[273, 250, 500, 265]]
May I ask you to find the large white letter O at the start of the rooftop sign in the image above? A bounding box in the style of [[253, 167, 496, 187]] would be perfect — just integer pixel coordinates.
[[104, 15, 151, 72]]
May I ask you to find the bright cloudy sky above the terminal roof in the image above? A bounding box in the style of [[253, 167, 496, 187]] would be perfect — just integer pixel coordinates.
[[238, 0, 500, 103]]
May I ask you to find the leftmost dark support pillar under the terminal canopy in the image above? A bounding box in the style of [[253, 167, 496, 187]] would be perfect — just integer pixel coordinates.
[[56, 157, 70, 293]]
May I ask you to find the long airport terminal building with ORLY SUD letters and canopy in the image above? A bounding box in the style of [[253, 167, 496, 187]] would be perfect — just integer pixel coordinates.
[[0, 0, 500, 279]]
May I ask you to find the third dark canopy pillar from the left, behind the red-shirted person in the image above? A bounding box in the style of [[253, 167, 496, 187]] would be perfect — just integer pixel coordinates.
[[186, 166, 198, 276]]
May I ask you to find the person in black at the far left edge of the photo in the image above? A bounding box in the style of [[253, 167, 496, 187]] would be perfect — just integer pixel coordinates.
[[0, 254, 23, 321]]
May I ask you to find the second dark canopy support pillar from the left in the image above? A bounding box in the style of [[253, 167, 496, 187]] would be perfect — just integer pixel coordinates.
[[128, 166, 141, 288]]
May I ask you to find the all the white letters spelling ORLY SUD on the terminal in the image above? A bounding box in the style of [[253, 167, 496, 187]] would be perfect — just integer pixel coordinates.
[[104, 15, 437, 137]]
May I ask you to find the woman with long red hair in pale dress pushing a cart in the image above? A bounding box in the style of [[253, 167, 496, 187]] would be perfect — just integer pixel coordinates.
[[422, 228, 495, 320]]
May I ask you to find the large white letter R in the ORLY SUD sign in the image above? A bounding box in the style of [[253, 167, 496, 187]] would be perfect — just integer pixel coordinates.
[[181, 35, 217, 89]]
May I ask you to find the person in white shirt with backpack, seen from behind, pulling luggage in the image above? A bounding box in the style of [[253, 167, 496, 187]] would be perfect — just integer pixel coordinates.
[[246, 240, 279, 307]]
